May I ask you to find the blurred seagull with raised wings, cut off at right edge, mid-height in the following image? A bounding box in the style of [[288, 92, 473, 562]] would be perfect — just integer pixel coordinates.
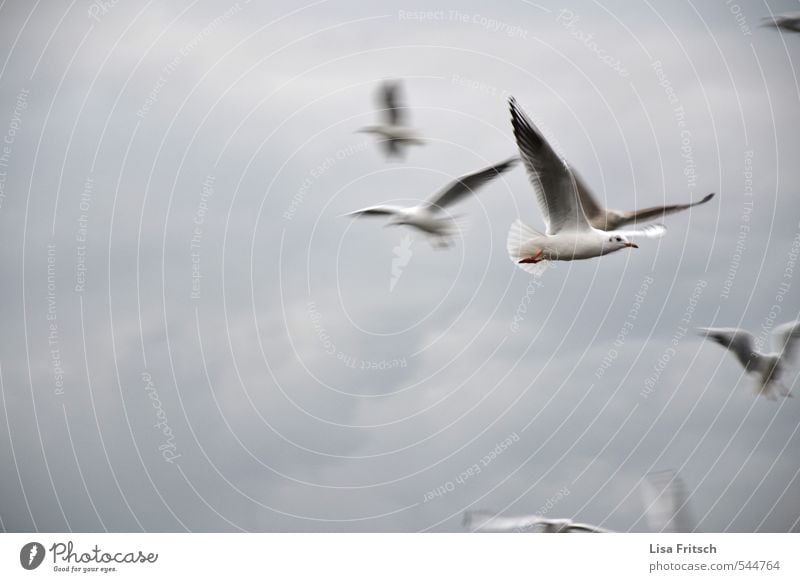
[[697, 321, 800, 400]]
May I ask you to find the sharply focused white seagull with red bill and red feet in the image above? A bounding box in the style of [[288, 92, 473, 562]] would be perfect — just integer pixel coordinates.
[[507, 97, 667, 275]]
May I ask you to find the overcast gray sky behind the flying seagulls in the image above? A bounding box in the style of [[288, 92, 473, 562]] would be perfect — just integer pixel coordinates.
[[0, 0, 800, 531]]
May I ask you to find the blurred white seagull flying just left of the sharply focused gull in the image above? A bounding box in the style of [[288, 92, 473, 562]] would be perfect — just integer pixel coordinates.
[[344, 157, 519, 247]]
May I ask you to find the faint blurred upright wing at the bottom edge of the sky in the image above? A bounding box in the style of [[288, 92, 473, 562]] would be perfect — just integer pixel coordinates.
[[641, 470, 693, 533]]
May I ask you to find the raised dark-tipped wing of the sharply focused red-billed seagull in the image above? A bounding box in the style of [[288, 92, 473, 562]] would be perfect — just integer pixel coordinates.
[[508, 97, 590, 234]]
